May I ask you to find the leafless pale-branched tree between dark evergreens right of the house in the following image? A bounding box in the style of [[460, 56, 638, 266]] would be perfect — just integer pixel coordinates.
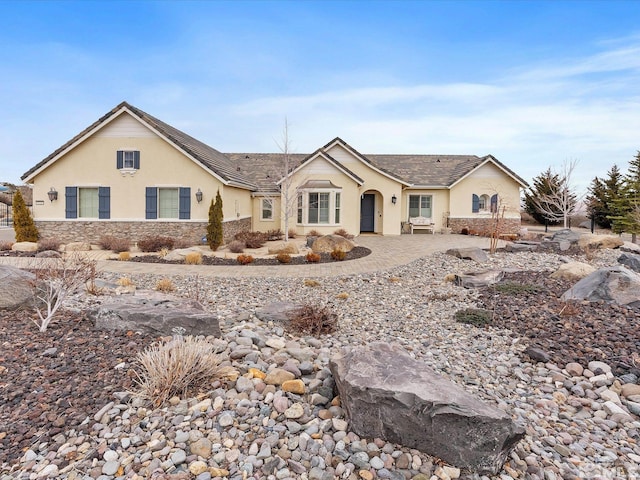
[[533, 160, 578, 228]]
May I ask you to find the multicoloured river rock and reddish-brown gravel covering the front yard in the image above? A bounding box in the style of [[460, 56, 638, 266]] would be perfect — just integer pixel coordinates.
[[0, 251, 640, 480]]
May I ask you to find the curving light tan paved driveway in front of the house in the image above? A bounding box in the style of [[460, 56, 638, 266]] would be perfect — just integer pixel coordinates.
[[0, 234, 504, 278]]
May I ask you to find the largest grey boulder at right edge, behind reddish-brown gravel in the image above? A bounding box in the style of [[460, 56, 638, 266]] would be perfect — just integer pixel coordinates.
[[561, 265, 640, 306]]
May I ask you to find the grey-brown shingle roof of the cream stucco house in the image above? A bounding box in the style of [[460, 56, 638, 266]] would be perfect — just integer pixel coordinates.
[[22, 102, 527, 192]]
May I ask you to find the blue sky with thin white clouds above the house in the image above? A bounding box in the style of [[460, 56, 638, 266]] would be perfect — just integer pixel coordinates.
[[0, 0, 640, 193]]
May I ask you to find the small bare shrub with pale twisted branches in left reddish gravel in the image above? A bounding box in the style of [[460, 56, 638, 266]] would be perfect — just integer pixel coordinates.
[[33, 255, 96, 332]]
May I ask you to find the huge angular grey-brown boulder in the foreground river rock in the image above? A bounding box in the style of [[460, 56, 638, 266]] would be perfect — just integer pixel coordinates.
[[330, 342, 524, 474]]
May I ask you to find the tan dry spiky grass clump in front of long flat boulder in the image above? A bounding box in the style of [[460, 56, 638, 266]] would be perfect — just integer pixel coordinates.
[[136, 336, 238, 407]]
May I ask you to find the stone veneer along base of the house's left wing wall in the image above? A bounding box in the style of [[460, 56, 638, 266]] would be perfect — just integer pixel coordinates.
[[35, 217, 251, 245]]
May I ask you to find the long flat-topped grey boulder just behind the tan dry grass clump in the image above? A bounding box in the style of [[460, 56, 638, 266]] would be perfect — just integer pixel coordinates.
[[88, 291, 220, 337]]
